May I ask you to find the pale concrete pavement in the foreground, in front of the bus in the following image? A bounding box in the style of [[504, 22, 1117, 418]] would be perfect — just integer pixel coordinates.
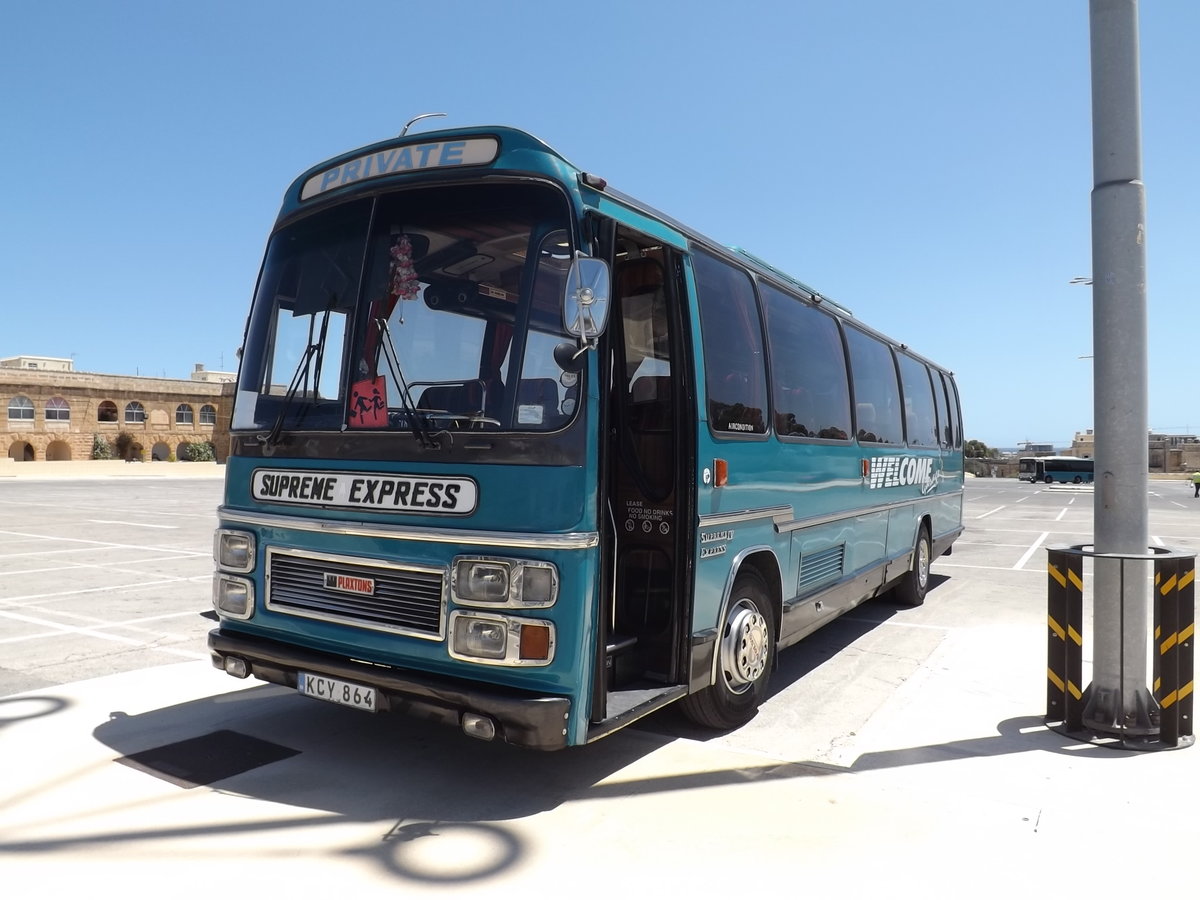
[[0, 630, 1200, 898]]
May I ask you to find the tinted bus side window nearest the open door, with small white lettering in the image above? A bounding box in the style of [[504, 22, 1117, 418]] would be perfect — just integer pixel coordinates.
[[692, 252, 767, 434]]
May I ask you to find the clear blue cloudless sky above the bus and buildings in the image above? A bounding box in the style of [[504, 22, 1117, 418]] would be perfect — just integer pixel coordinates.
[[0, 0, 1200, 446]]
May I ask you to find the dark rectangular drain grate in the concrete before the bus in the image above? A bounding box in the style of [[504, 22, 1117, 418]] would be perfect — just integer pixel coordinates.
[[116, 731, 300, 787]]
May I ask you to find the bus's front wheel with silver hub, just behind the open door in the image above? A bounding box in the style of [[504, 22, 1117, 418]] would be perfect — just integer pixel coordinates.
[[680, 570, 775, 731]]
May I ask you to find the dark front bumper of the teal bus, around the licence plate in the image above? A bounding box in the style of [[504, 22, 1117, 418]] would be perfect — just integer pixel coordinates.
[[209, 629, 571, 750]]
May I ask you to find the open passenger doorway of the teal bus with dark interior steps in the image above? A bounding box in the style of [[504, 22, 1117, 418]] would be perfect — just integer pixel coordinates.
[[593, 230, 695, 720]]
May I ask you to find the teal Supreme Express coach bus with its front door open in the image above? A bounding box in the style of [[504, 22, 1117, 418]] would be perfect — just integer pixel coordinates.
[[209, 127, 962, 750]]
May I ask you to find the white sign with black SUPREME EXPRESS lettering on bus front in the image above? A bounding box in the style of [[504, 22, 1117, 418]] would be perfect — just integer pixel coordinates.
[[250, 469, 479, 516]]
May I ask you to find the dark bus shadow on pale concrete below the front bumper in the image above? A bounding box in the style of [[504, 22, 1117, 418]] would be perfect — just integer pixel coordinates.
[[94, 685, 670, 821]]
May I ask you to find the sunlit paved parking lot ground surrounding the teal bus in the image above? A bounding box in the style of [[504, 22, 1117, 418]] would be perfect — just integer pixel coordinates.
[[0, 479, 1200, 898]]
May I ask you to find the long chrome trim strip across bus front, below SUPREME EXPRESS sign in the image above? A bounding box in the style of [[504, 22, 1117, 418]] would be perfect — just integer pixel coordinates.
[[217, 506, 600, 550]]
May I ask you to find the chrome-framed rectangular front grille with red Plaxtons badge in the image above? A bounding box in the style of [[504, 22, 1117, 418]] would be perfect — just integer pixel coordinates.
[[266, 550, 445, 640]]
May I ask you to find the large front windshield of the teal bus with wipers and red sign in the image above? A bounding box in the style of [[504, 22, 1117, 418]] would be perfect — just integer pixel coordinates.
[[233, 185, 576, 438]]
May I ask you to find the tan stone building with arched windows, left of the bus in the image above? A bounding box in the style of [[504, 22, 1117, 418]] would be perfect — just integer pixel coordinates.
[[0, 356, 233, 462]]
